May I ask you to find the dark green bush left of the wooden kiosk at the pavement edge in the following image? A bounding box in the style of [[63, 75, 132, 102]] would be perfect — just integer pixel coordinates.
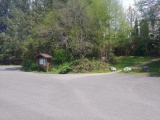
[[22, 60, 38, 71]]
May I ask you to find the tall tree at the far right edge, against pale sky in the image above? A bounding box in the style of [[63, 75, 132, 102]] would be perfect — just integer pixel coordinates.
[[136, 0, 160, 54]]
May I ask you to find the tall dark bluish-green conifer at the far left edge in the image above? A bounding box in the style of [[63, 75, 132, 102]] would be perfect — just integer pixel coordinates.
[[1, 0, 31, 64]]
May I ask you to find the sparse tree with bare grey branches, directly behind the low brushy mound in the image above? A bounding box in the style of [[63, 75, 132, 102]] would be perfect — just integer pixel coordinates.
[[56, 0, 93, 58]]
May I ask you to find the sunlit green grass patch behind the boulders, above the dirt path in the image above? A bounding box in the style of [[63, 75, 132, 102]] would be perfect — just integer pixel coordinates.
[[113, 56, 153, 70]]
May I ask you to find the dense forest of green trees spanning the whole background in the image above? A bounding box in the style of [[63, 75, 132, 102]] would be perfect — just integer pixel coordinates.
[[0, 0, 160, 70]]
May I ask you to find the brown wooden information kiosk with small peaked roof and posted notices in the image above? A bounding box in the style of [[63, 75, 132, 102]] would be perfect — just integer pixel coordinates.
[[34, 53, 52, 72]]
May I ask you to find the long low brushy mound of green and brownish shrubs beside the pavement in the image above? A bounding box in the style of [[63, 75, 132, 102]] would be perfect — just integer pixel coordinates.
[[50, 59, 107, 74]]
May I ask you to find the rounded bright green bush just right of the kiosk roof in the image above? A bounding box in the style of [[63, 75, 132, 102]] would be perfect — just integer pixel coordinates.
[[53, 49, 73, 64]]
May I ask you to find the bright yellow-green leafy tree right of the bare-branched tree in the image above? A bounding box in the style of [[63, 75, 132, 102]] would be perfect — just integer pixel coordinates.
[[91, 0, 128, 59]]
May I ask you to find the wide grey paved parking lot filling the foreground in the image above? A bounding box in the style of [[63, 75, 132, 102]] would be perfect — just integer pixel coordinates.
[[0, 66, 160, 120]]
